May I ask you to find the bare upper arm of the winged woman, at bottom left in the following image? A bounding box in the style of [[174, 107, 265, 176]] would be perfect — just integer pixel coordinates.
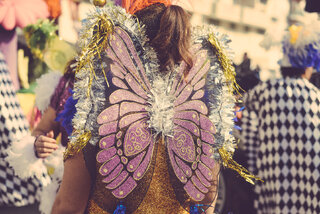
[[51, 152, 91, 214]]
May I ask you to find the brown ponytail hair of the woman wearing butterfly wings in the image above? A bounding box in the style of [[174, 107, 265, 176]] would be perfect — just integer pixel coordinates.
[[136, 4, 193, 71]]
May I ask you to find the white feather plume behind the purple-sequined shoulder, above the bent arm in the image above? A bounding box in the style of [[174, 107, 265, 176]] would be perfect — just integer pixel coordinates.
[[35, 71, 62, 112]]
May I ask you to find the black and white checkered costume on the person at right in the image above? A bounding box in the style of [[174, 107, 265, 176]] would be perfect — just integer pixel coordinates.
[[241, 78, 320, 214]]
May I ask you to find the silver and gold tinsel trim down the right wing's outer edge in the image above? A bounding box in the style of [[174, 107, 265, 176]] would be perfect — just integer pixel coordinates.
[[193, 25, 262, 184]]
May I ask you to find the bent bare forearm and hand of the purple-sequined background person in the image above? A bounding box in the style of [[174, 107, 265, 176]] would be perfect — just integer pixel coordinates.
[[32, 106, 58, 158]]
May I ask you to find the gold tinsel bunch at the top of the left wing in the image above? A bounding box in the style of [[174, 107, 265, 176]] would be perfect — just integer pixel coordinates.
[[76, 14, 114, 96]]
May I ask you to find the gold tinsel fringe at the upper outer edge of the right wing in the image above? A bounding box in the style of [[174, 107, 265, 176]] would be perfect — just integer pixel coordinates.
[[208, 33, 243, 94]]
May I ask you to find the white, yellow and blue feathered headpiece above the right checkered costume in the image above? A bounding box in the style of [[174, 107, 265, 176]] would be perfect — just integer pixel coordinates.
[[281, 21, 320, 71]]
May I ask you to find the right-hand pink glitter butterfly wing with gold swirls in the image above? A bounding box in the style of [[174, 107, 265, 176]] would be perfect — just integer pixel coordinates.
[[166, 50, 217, 202]]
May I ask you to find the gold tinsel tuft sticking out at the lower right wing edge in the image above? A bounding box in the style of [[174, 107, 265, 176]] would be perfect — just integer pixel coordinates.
[[218, 147, 263, 184]]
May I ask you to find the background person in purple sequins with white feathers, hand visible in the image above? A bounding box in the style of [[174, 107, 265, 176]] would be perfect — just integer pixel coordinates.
[[6, 59, 76, 214]]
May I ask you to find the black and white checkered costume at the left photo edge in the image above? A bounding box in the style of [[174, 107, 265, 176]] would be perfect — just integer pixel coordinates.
[[0, 52, 40, 206]]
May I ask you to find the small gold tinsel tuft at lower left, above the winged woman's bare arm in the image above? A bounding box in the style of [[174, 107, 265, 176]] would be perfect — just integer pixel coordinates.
[[63, 131, 91, 160]]
